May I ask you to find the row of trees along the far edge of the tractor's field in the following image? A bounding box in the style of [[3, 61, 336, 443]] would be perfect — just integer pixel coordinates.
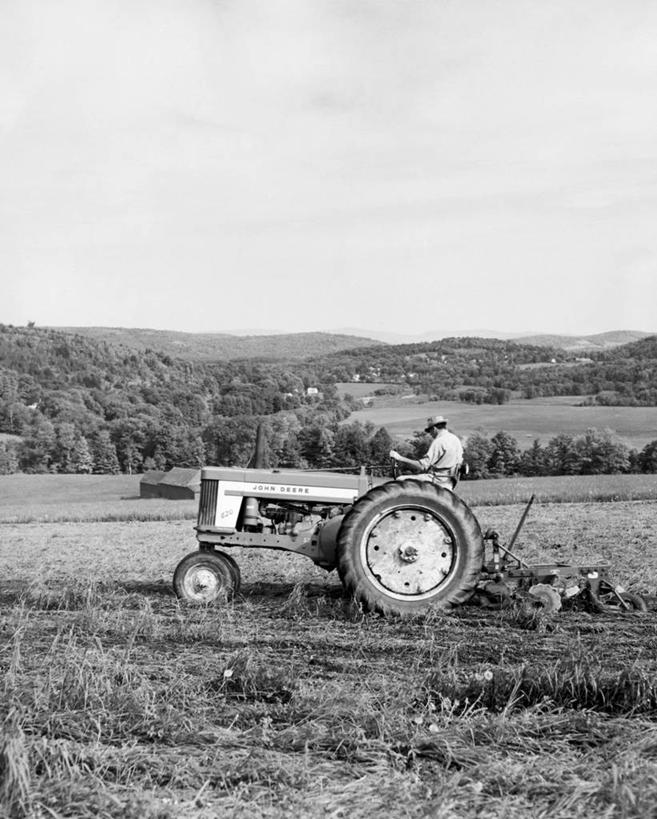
[[0, 413, 657, 479]]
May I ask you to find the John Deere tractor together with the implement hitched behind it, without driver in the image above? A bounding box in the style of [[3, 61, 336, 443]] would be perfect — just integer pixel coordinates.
[[173, 467, 646, 616]]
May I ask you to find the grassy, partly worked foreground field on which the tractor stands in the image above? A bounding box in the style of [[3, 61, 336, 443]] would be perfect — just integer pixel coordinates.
[[0, 476, 657, 819]]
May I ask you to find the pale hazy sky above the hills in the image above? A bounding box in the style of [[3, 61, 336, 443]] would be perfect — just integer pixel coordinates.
[[0, 0, 657, 333]]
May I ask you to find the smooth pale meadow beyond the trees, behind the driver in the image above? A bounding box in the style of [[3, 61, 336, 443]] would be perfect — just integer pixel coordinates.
[[340, 394, 657, 450]]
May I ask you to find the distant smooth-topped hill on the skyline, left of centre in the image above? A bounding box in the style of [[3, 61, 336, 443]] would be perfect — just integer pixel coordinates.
[[49, 327, 382, 361]]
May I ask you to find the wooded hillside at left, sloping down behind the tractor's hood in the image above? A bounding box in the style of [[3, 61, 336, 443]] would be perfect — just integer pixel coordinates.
[[0, 325, 348, 472]]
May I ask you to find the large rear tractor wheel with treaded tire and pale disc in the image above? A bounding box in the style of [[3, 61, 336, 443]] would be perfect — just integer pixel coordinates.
[[337, 480, 484, 616]]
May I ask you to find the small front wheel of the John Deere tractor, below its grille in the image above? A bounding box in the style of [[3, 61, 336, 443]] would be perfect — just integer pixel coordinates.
[[173, 551, 235, 604]]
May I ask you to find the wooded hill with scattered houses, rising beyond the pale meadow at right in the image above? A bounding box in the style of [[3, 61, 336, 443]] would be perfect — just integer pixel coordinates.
[[307, 336, 657, 406]]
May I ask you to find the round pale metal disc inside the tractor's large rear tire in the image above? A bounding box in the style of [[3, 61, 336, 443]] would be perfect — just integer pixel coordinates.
[[364, 507, 455, 597]]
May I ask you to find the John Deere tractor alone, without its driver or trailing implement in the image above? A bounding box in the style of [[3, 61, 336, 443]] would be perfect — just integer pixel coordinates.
[[174, 467, 483, 614]]
